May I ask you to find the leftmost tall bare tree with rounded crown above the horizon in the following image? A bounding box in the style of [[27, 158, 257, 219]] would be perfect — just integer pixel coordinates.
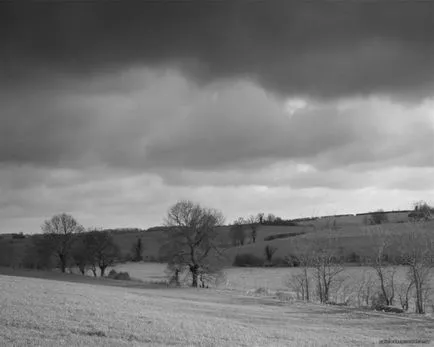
[[41, 213, 83, 272]]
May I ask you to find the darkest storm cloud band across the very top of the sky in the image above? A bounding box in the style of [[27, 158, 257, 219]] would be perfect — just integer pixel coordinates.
[[0, 1, 434, 97]]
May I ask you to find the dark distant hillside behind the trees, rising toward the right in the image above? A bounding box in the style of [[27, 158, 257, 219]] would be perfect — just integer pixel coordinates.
[[0, 211, 424, 270]]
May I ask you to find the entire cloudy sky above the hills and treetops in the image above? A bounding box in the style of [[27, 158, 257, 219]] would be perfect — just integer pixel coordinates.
[[0, 0, 434, 233]]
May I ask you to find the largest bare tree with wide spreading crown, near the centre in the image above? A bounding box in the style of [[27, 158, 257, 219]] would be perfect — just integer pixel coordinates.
[[162, 200, 224, 287]]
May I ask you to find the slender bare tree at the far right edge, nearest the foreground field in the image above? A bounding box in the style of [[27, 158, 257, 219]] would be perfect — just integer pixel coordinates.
[[401, 225, 434, 313]]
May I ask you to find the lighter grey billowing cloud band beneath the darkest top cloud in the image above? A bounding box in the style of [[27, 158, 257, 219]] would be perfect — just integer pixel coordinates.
[[0, 70, 434, 174]]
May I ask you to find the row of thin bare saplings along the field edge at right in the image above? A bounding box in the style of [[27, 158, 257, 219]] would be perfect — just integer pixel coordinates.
[[287, 223, 434, 313]]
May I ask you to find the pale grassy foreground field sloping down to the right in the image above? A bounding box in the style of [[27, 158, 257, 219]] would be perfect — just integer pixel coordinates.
[[0, 275, 434, 346]]
